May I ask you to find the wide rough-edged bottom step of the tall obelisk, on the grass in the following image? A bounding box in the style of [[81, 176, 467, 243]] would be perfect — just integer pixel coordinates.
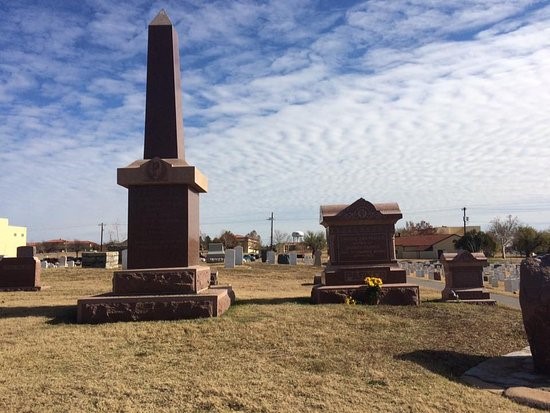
[[77, 286, 235, 324]]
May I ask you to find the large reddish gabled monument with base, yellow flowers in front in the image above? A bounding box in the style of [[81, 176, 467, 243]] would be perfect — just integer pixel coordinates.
[[312, 198, 420, 305]]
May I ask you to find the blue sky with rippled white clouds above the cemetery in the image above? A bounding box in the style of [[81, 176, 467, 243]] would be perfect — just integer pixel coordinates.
[[0, 0, 550, 243]]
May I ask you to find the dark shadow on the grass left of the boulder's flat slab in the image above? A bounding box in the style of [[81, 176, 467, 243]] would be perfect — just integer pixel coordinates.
[[395, 350, 489, 379]]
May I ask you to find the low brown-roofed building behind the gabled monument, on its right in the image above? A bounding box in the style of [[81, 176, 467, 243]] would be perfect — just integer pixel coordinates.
[[395, 234, 460, 260]]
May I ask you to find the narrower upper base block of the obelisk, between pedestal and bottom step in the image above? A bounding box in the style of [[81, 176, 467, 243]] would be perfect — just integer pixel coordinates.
[[113, 265, 210, 295]]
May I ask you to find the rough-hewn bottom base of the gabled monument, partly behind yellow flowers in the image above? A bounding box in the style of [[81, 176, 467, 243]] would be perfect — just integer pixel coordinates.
[[311, 283, 420, 305]]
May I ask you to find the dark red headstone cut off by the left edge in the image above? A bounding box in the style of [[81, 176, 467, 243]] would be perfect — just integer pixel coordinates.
[[0, 247, 44, 291]]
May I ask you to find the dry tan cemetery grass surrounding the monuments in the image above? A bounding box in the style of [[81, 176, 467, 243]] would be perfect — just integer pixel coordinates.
[[0, 262, 536, 412]]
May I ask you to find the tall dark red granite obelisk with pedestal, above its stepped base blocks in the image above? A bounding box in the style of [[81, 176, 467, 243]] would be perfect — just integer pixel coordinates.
[[118, 10, 207, 269]]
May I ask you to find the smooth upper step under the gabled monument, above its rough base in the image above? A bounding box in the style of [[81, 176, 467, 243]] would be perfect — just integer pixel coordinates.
[[322, 263, 407, 285]]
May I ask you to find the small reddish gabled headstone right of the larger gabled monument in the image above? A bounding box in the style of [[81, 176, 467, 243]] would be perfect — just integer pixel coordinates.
[[441, 251, 495, 304]]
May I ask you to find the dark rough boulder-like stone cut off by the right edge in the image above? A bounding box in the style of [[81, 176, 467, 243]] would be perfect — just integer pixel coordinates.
[[519, 254, 550, 374]]
